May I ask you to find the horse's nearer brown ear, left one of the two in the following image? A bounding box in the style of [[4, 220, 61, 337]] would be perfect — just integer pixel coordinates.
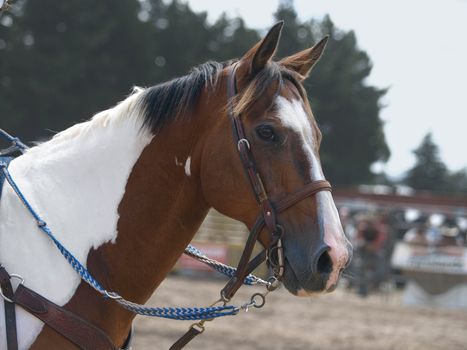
[[242, 21, 284, 75]]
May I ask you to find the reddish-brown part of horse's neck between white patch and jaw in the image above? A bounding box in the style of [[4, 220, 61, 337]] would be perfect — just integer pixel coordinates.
[[89, 118, 208, 303]]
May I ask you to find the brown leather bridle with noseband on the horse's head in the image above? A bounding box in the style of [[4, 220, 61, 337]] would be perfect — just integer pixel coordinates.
[[221, 64, 331, 301]]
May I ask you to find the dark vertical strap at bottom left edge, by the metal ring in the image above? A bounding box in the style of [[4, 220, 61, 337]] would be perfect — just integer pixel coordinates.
[[0, 266, 18, 350]]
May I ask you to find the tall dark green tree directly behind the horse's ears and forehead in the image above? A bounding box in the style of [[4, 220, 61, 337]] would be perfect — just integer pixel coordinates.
[[275, 1, 390, 185]]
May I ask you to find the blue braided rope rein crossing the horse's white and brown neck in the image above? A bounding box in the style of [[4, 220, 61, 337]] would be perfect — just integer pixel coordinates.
[[0, 162, 247, 320]]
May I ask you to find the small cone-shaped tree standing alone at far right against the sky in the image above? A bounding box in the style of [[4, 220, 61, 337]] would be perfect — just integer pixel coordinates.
[[405, 133, 449, 191]]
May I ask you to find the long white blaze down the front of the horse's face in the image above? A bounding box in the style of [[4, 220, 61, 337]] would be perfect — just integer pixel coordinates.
[[276, 96, 348, 289]]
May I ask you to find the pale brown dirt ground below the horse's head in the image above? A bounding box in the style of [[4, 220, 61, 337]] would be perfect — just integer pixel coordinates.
[[133, 276, 467, 350]]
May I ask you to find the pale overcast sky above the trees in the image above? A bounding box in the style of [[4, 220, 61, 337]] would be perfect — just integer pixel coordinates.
[[185, 0, 467, 177]]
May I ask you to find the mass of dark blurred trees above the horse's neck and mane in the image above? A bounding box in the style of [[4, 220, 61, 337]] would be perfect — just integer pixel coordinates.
[[0, 0, 258, 140]]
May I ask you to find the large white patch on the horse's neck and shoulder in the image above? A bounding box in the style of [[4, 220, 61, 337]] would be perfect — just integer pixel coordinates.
[[0, 91, 152, 349]]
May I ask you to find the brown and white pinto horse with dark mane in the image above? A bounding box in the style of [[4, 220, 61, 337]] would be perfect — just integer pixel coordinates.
[[0, 22, 351, 349]]
